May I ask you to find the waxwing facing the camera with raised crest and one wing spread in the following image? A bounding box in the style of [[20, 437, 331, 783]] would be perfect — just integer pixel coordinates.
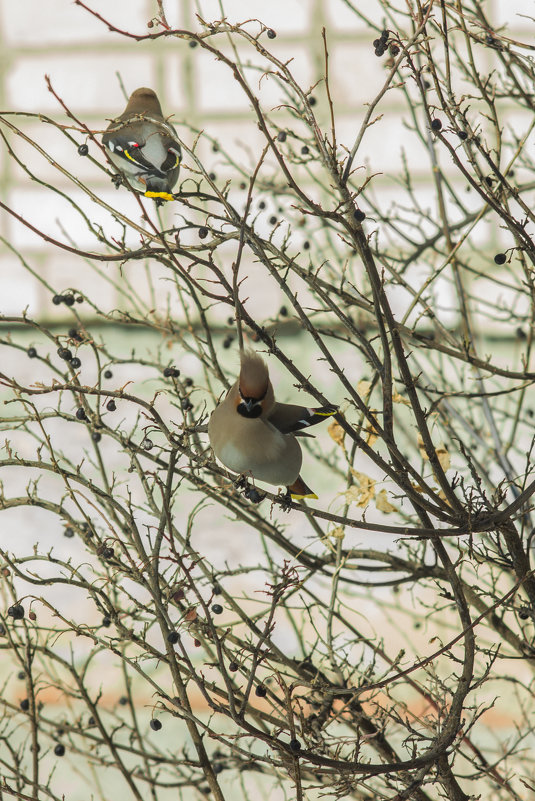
[[208, 350, 336, 500]]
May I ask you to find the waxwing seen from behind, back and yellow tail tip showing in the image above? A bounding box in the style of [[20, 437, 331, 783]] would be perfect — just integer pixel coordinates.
[[102, 87, 182, 200]]
